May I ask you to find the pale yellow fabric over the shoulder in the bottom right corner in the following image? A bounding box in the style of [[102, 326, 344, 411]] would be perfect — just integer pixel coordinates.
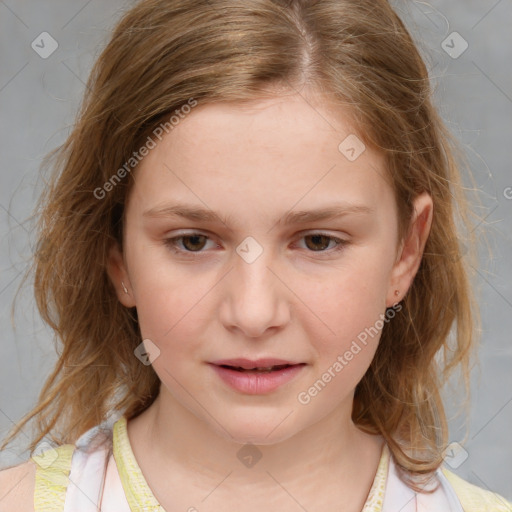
[[442, 468, 512, 512]]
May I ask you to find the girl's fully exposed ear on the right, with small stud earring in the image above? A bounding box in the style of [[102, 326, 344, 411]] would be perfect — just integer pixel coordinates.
[[386, 192, 434, 307]]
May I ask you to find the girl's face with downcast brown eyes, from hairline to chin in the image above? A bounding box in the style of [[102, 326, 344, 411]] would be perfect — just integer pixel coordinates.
[[109, 91, 428, 444]]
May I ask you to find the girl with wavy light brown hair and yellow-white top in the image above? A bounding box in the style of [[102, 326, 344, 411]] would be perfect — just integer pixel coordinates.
[[1, 0, 512, 512]]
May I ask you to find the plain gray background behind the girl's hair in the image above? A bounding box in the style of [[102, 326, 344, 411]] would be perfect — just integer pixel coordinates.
[[0, 0, 512, 500]]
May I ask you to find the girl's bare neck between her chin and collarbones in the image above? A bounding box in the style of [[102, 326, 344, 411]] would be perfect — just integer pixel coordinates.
[[128, 388, 383, 497]]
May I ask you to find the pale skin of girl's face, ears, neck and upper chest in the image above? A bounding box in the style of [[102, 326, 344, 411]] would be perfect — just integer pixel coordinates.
[[104, 93, 433, 512]]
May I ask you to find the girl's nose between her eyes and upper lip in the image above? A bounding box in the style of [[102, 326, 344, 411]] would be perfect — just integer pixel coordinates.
[[220, 241, 291, 338]]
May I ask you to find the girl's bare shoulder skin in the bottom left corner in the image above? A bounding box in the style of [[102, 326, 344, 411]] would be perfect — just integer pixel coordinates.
[[0, 459, 36, 512]]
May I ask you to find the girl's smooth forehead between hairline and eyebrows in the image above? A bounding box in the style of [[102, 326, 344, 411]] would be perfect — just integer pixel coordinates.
[[126, 94, 391, 224]]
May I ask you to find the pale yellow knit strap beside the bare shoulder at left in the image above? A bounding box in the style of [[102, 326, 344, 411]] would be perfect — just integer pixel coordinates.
[[31, 444, 75, 512]]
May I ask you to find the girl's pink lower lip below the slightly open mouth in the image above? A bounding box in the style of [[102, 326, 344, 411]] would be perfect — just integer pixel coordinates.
[[212, 364, 305, 395]]
